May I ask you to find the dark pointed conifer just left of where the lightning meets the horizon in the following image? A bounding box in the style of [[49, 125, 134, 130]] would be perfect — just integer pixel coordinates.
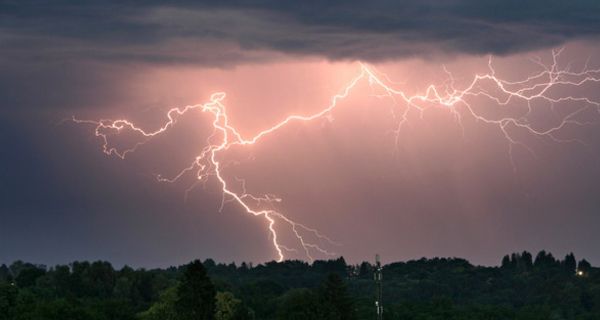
[[175, 260, 216, 320]]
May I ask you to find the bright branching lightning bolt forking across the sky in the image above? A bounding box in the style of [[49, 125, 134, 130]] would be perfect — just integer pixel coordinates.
[[72, 48, 600, 261]]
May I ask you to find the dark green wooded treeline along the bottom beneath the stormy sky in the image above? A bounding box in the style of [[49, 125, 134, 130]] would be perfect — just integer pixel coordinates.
[[0, 251, 600, 320]]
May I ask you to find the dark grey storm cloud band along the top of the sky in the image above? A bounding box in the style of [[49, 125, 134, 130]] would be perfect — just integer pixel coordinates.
[[0, 0, 600, 65]]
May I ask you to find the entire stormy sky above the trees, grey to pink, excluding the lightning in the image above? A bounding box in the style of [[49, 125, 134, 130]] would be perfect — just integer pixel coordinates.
[[0, 0, 600, 267]]
